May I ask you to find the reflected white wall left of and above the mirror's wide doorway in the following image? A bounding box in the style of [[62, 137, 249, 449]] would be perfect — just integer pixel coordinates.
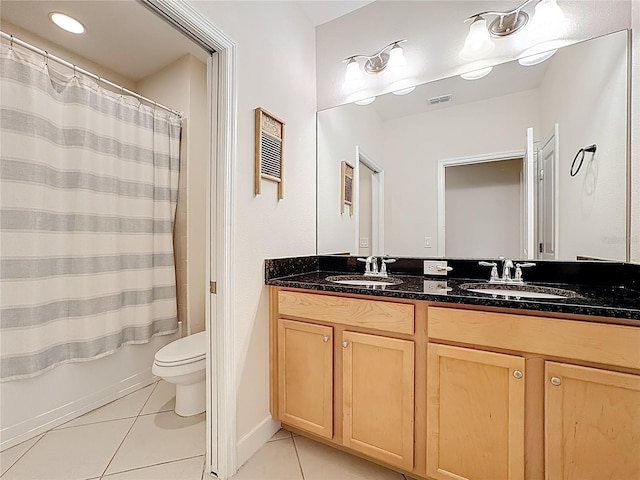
[[384, 90, 538, 257]]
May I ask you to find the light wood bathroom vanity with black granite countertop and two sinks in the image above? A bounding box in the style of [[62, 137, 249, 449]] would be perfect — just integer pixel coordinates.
[[266, 257, 640, 480]]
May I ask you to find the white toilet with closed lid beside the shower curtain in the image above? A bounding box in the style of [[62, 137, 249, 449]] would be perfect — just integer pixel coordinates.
[[151, 332, 207, 417]]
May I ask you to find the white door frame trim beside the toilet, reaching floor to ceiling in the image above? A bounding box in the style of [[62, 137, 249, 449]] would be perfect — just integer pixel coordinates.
[[138, 0, 237, 480]]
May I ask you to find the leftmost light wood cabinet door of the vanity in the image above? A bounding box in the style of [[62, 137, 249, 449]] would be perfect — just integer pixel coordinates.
[[278, 319, 333, 438]]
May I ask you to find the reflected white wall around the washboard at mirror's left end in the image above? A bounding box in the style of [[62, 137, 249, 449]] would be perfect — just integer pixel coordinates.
[[318, 105, 384, 255]]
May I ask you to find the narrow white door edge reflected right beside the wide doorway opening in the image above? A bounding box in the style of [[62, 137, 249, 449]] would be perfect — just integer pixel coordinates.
[[521, 127, 536, 259]]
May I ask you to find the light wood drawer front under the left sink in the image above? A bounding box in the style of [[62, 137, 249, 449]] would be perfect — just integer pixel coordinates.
[[278, 290, 414, 334]]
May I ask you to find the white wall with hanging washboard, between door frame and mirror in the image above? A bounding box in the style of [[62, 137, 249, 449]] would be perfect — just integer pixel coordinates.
[[185, 1, 316, 464]]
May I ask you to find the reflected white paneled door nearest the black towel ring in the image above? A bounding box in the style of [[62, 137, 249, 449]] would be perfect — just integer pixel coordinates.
[[536, 123, 559, 260]]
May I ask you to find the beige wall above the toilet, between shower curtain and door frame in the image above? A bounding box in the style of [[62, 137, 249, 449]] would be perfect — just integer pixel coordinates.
[[136, 54, 209, 334]]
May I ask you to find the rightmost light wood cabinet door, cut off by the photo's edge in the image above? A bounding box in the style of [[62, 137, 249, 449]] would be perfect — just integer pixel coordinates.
[[545, 362, 640, 480]]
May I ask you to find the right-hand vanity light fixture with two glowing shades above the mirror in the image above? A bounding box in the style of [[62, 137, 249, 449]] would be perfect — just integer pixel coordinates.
[[459, 0, 567, 60]]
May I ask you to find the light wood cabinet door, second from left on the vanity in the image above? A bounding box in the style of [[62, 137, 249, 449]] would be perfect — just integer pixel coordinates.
[[342, 332, 414, 470]]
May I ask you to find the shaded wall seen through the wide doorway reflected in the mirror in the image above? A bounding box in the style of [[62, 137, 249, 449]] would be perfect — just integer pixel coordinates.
[[444, 158, 525, 258]]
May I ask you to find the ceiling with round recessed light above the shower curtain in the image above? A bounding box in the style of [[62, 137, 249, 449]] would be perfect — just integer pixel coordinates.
[[0, 0, 208, 82]]
